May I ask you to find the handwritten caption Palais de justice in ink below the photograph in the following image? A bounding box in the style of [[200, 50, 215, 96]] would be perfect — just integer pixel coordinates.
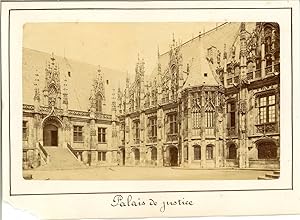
[[110, 195, 194, 212]]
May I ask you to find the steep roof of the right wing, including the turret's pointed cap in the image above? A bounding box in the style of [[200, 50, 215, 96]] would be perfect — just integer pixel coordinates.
[[151, 22, 255, 88]]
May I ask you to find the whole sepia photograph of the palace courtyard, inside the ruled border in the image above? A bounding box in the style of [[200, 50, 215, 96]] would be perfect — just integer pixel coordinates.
[[20, 21, 281, 180]]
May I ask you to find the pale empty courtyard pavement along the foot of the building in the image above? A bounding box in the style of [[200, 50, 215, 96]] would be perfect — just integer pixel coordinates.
[[23, 167, 271, 180]]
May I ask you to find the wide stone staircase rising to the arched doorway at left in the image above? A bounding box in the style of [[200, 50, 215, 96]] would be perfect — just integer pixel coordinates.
[[37, 146, 87, 170]]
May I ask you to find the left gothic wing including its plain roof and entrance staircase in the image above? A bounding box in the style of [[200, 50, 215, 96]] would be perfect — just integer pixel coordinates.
[[23, 48, 118, 169]]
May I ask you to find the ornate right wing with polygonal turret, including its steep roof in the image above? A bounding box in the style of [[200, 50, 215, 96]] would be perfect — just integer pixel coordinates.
[[117, 23, 280, 169]]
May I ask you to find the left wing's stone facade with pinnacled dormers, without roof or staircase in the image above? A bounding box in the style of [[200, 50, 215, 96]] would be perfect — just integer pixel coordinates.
[[23, 55, 118, 169]]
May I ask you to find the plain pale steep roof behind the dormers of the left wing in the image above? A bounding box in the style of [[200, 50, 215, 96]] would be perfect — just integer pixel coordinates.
[[23, 48, 126, 114]]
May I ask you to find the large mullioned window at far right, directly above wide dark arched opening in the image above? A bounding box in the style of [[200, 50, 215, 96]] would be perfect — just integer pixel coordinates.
[[258, 95, 275, 124]]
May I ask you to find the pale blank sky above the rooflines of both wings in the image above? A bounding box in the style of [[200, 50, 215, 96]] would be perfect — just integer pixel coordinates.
[[23, 22, 221, 74]]
